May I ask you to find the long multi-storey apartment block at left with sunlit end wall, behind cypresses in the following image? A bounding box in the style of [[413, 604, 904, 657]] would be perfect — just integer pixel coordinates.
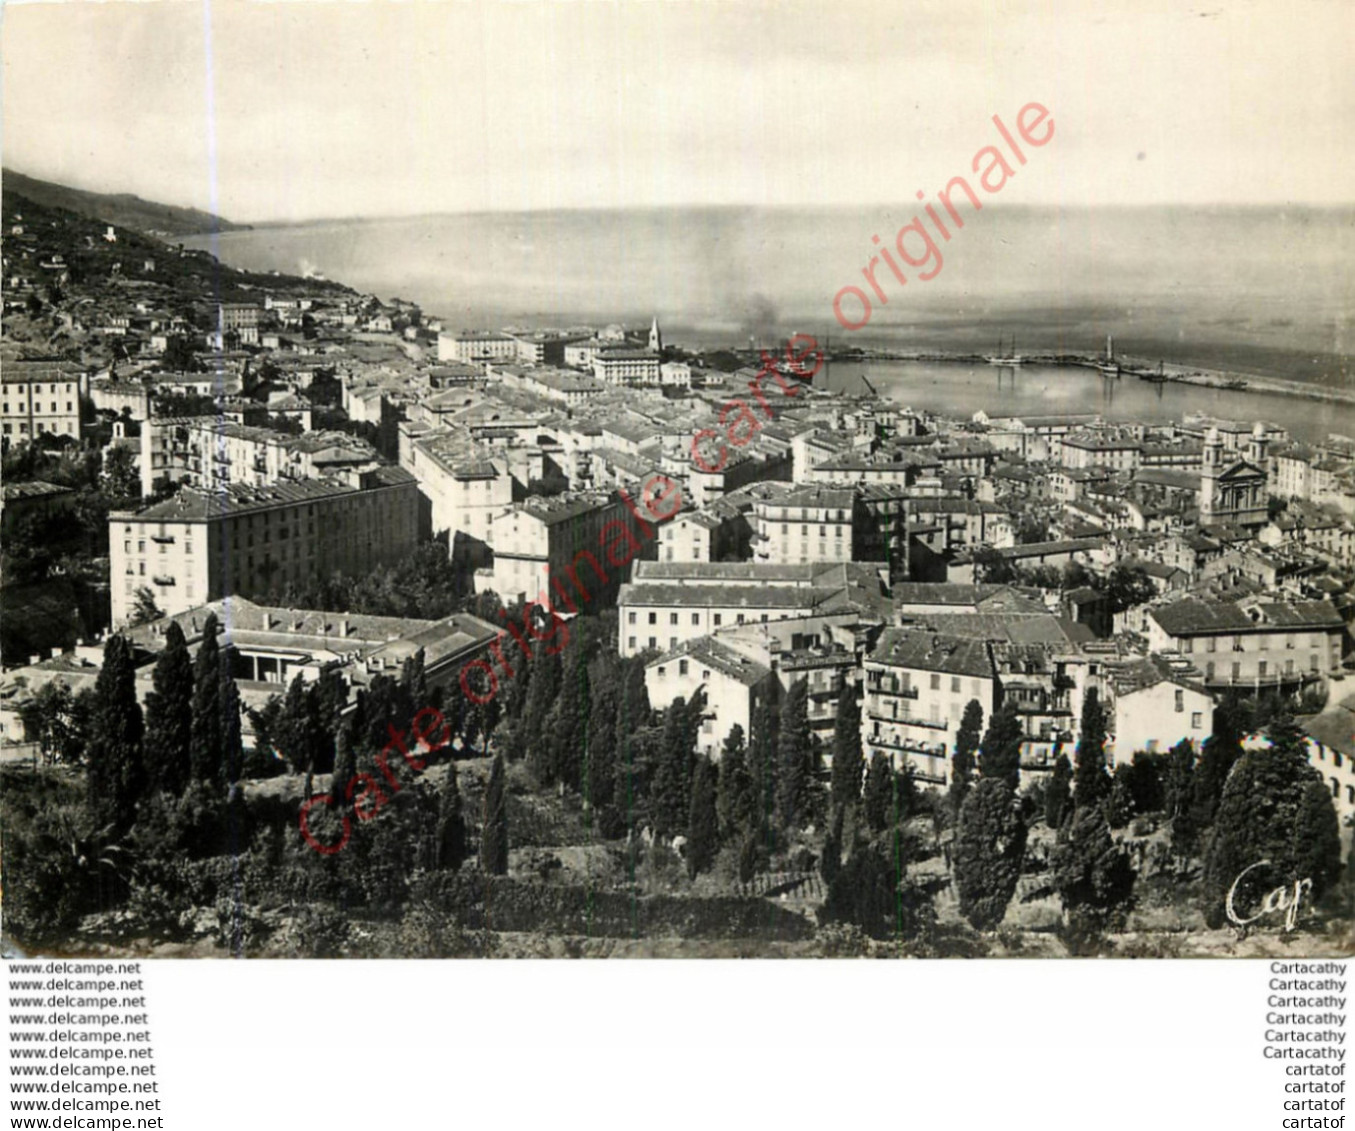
[[108, 467, 419, 626]]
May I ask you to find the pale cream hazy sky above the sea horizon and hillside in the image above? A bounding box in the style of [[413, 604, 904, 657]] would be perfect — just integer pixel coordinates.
[[0, 0, 1355, 221]]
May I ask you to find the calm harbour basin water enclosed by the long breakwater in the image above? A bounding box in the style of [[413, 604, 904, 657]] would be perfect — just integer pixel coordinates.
[[827, 362, 1355, 443]]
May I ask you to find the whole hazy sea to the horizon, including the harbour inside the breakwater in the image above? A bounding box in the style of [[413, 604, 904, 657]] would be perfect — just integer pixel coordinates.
[[188, 202, 1355, 439]]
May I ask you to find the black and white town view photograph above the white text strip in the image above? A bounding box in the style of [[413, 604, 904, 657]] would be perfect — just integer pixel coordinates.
[[0, 0, 1355, 964]]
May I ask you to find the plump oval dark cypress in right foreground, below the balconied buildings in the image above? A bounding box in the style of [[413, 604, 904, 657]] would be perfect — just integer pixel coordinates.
[[953, 773, 1026, 931]]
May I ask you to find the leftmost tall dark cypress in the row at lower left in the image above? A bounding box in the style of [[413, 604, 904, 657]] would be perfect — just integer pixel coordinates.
[[85, 634, 146, 833]]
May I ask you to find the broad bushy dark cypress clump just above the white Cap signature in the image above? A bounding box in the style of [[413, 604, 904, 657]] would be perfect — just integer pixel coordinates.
[[1205, 715, 1340, 924]]
